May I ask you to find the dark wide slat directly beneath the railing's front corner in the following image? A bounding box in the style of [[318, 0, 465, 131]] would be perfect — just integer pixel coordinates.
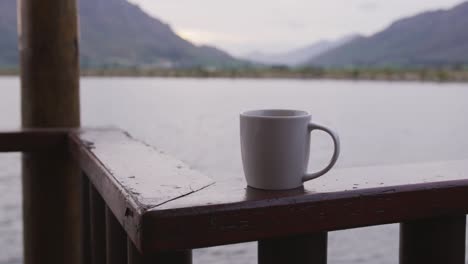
[[127, 239, 192, 264]]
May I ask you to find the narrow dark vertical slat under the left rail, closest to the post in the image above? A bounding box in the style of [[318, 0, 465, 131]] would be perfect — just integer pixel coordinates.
[[81, 173, 91, 264]]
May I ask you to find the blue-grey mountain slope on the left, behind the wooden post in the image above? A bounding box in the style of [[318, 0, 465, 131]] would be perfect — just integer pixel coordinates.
[[0, 0, 240, 67]]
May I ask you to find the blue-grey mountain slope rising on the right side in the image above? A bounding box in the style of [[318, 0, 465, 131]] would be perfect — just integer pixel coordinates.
[[307, 2, 468, 67]]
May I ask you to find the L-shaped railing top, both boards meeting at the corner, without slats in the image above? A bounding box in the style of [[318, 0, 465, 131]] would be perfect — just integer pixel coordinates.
[[66, 130, 468, 253]]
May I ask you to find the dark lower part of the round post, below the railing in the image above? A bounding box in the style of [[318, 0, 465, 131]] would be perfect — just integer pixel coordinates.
[[22, 150, 81, 264]]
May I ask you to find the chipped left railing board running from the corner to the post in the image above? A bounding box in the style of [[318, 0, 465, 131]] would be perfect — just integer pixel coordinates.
[[70, 129, 214, 248]]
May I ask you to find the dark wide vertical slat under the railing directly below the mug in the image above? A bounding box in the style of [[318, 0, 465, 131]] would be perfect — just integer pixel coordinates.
[[258, 232, 328, 264]]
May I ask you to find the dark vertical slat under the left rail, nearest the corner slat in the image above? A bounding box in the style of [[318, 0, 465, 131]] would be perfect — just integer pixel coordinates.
[[106, 207, 127, 264]]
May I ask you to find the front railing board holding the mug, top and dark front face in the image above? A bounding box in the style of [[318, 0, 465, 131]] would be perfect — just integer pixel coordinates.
[[144, 160, 468, 249]]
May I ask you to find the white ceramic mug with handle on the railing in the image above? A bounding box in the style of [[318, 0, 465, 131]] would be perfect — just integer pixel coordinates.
[[240, 109, 340, 190]]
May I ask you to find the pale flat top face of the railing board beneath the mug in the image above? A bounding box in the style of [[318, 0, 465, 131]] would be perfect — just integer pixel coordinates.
[[159, 160, 468, 209]]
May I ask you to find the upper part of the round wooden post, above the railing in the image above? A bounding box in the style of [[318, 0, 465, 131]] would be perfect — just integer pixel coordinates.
[[18, 0, 80, 128]]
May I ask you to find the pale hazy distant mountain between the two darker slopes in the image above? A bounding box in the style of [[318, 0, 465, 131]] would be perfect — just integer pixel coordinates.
[[244, 35, 360, 66]]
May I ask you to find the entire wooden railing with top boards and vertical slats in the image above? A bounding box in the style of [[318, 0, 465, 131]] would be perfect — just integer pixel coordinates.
[[0, 129, 468, 264]]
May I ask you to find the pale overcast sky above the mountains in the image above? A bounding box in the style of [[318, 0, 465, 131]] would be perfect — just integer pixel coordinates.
[[130, 0, 463, 55]]
